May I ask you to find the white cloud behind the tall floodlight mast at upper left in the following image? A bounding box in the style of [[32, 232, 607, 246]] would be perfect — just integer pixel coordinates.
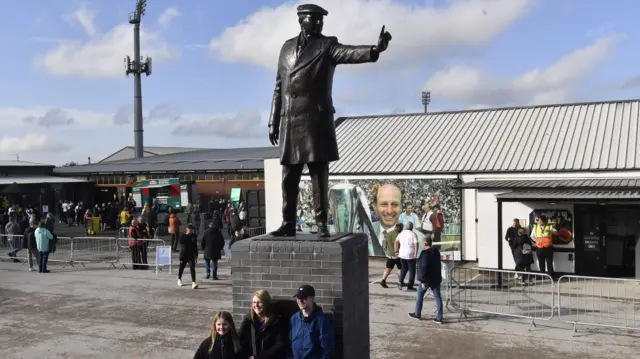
[[34, 4, 178, 78]]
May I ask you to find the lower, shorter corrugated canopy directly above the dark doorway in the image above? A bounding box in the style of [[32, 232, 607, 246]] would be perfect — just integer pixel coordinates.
[[496, 190, 640, 200]]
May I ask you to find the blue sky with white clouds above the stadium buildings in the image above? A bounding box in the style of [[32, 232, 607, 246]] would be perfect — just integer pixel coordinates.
[[0, 0, 640, 165]]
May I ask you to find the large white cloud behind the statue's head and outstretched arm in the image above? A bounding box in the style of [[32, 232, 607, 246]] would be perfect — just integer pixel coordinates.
[[209, 0, 533, 70]]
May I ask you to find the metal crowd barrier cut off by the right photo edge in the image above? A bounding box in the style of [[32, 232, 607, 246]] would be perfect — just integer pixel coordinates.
[[558, 275, 640, 335]]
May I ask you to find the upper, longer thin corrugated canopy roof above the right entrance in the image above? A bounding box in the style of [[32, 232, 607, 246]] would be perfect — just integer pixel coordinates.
[[456, 178, 640, 189]]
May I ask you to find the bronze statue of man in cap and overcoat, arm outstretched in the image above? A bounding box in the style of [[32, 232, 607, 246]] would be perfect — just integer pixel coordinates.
[[269, 4, 391, 237]]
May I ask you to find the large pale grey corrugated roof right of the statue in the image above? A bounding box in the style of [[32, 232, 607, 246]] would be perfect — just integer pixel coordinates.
[[330, 100, 640, 174]]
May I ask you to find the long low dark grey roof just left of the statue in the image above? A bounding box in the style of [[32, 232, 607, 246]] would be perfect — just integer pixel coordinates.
[[53, 147, 280, 175]]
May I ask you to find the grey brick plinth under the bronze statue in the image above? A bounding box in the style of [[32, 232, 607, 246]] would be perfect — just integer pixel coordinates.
[[231, 233, 370, 359]]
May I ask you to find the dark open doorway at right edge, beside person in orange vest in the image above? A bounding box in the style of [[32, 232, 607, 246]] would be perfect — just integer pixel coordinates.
[[574, 204, 640, 278]]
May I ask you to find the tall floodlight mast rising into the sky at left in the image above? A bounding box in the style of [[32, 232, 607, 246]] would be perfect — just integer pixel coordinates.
[[124, 0, 151, 158]]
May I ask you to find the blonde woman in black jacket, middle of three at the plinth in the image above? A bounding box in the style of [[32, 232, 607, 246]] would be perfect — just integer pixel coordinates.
[[240, 289, 289, 359]]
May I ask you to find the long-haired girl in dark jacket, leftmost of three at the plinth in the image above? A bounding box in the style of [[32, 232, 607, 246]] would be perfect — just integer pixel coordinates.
[[193, 312, 245, 359]]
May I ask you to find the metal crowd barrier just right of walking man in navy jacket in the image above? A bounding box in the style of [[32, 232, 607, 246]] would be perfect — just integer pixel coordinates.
[[447, 267, 555, 330]]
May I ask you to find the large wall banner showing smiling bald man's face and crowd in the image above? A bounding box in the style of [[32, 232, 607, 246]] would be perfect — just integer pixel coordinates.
[[298, 179, 461, 256]]
